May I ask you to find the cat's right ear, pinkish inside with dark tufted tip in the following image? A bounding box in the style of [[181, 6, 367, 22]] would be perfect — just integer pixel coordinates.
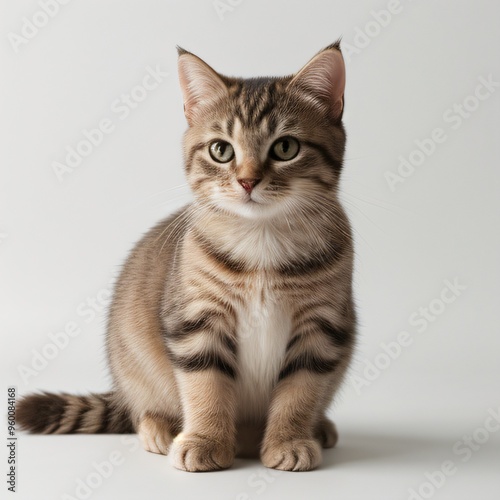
[[289, 42, 345, 120]]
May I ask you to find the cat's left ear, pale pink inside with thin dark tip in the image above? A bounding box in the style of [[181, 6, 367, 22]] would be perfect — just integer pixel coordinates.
[[177, 47, 227, 125]]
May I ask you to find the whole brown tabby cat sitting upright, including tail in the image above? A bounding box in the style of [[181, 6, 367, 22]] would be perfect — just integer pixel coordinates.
[[17, 42, 356, 471]]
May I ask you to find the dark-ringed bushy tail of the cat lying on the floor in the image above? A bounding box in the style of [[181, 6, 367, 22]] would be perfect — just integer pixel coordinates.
[[16, 392, 134, 434]]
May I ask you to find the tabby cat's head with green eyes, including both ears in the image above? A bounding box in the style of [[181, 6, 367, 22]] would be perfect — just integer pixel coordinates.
[[179, 43, 345, 218]]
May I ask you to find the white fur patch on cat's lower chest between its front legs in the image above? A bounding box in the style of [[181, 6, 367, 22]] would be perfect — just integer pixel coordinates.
[[237, 278, 291, 420]]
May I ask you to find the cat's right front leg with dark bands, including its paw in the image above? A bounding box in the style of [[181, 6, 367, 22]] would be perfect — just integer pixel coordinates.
[[261, 319, 353, 471]]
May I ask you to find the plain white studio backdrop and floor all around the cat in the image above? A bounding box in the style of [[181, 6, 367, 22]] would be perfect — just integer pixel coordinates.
[[0, 0, 500, 500]]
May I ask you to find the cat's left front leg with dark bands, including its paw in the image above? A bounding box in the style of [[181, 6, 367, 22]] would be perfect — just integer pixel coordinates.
[[168, 308, 236, 472]]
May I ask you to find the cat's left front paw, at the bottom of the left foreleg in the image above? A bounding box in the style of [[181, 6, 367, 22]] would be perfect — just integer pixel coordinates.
[[171, 433, 235, 472]]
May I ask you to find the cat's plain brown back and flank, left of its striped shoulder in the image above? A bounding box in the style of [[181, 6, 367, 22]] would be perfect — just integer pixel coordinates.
[[106, 205, 190, 414]]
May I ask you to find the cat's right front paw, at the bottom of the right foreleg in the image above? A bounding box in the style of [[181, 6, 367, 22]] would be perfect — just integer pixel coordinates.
[[261, 439, 321, 471]]
